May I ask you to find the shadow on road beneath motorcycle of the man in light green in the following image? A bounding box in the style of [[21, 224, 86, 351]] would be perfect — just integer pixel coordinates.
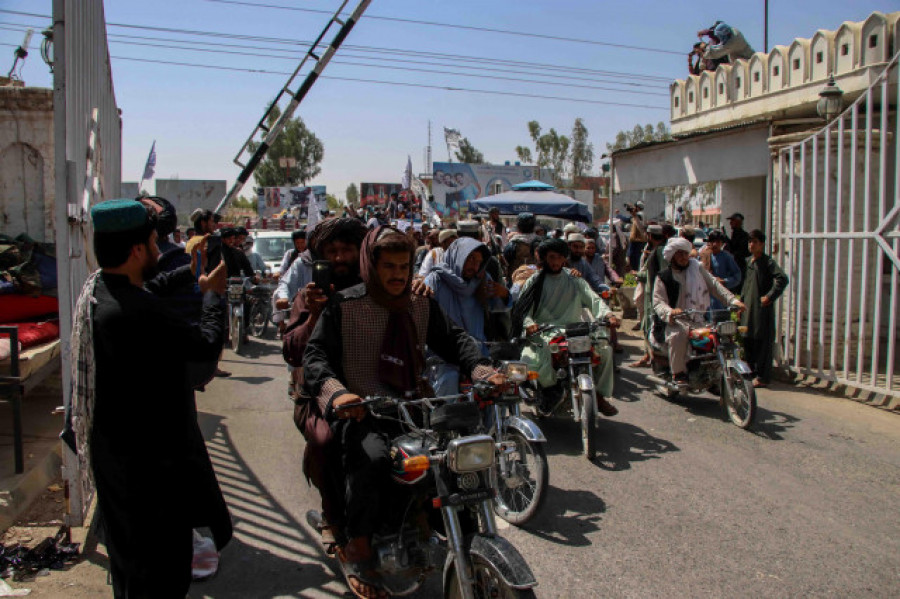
[[539, 416, 679, 471]]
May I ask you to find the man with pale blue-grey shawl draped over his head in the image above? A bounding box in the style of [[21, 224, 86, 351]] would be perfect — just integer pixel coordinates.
[[425, 237, 509, 395]]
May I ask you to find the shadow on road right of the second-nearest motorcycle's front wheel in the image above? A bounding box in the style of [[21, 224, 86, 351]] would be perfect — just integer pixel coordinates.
[[523, 485, 606, 547]]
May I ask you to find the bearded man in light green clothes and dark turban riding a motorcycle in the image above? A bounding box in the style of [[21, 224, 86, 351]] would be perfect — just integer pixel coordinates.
[[513, 239, 619, 416]]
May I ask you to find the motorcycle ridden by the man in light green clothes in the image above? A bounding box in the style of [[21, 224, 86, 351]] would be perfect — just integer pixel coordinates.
[[519, 321, 609, 460]]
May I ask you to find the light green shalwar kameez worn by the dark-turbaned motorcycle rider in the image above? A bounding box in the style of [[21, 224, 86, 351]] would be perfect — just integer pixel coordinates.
[[522, 271, 613, 397]]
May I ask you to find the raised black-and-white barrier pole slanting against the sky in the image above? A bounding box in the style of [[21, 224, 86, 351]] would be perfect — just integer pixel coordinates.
[[215, 0, 372, 213]]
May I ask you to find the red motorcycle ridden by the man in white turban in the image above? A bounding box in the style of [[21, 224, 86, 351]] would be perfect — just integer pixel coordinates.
[[647, 310, 756, 429]]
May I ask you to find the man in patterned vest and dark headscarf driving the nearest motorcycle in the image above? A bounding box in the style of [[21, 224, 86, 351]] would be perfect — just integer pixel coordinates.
[[303, 227, 505, 597]]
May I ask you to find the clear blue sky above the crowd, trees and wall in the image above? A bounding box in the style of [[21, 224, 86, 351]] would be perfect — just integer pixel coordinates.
[[0, 0, 900, 202]]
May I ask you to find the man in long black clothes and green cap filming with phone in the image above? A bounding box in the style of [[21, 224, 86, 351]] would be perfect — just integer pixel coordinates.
[[72, 200, 232, 598]]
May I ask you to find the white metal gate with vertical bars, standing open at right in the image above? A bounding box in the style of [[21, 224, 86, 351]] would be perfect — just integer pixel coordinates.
[[771, 54, 900, 401]]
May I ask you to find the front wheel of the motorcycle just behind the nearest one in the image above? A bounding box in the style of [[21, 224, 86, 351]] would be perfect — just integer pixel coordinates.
[[491, 430, 550, 526]]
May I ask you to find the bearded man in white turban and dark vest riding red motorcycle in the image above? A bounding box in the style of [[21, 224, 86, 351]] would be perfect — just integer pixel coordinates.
[[653, 237, 744, 384]]
